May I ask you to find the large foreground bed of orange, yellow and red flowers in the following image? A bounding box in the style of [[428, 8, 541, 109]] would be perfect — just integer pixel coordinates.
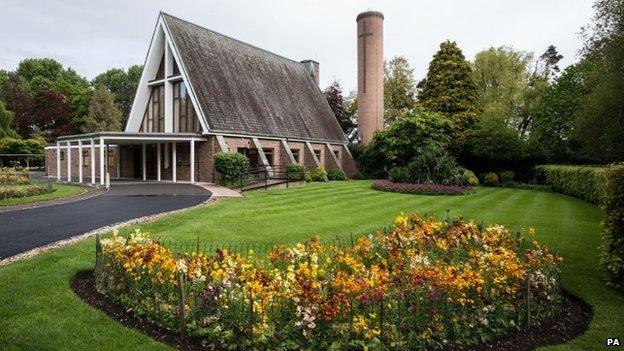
[[95, 215, 561, 350]]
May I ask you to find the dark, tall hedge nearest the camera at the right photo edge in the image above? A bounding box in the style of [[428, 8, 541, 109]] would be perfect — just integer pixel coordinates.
[[600, 163, 624, 290]]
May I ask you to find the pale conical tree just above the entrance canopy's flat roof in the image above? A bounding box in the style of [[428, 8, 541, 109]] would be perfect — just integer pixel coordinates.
[[82, 86, 122, 133]]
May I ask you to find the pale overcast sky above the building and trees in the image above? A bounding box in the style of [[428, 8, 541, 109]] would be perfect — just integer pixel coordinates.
[[0, 0, 593, 92]]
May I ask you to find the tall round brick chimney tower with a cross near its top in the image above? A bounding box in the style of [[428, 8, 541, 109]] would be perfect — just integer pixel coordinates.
[[356, 11, 384, 144]]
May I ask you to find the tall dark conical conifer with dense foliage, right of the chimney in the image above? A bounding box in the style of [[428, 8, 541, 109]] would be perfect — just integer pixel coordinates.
[[418, 40, 478, 125]]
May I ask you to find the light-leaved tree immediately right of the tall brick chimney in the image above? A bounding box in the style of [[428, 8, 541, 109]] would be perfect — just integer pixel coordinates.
[[384, 56, 416, 124]]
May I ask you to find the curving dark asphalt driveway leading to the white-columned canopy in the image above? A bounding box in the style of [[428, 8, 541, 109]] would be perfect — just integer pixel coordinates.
[[0, 183, 211, 259]]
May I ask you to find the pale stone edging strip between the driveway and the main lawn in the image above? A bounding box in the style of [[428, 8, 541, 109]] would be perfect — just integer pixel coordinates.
[[0, 197, 217, 267]]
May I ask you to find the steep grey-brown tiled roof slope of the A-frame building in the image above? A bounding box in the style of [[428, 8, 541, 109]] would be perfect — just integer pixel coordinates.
[[163, 14, 346, 142]]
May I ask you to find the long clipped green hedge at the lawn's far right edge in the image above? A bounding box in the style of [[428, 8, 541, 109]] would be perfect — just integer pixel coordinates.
[[535, 165, 606, 204]]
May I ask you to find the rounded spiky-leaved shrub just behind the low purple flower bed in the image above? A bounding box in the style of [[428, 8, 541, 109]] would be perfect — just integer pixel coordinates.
[[407, 144, 465, 185]]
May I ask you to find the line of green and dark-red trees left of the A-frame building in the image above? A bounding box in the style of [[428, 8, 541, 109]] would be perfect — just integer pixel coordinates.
[[0, 58, 142, 146]]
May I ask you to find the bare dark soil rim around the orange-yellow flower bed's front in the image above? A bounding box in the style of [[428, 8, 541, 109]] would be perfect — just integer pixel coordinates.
[[70, 271, 593, 351]]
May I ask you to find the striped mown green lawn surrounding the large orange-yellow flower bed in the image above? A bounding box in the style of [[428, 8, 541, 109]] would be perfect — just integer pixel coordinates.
[[0, 181, 624, 350]]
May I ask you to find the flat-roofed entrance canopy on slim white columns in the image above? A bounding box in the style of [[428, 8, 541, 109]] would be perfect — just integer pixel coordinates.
[[56, 132, 207, 185]]
